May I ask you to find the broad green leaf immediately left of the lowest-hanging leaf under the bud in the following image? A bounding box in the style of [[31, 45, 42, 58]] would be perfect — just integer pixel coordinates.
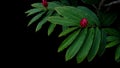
[[65, 28, 87, 61]]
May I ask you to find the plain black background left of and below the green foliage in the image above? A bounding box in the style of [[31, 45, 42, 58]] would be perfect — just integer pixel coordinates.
[[2, 0, 119, 66]]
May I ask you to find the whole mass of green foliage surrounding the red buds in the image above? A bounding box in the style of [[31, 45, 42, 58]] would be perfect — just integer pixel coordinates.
[[25, 0, 120, 63]]
